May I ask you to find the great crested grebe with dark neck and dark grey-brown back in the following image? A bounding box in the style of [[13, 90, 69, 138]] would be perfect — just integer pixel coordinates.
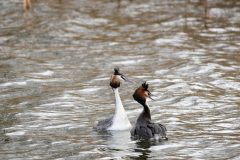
[[131, 82, 167, 140]]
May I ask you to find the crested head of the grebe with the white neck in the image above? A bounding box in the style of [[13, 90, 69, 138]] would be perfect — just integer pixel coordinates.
[[110, 68, 127, 88]]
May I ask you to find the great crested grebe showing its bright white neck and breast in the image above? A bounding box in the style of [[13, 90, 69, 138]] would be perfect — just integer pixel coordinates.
[[94, 68, 132, 131]]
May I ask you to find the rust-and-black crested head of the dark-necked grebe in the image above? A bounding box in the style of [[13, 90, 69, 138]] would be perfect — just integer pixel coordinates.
[[133, 82, 152, 105]]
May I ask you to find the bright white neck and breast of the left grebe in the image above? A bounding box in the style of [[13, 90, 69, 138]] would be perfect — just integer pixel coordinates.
[[109, 88, 132, 130]]
